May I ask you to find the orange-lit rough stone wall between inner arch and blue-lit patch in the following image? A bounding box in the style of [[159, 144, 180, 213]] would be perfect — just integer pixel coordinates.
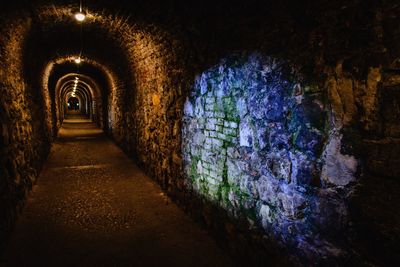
[[113, 27, 186, 192]]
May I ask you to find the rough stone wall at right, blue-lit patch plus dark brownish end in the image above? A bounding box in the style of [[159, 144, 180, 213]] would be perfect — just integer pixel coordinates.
[[178, 48, 399, 264]]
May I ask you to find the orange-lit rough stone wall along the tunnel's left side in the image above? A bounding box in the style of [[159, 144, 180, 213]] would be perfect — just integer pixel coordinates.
[[0, 14, 51, 249]]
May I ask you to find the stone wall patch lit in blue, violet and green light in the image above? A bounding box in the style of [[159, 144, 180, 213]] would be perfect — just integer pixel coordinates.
[[182, 54, 357, 258]]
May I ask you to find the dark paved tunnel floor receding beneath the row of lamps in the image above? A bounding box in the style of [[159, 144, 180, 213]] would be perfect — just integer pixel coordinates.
[[0, 117, 233, 266]]
